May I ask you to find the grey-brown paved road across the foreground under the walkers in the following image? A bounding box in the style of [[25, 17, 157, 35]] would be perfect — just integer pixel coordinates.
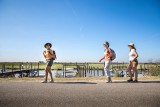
[[0, 81, 160, 107]]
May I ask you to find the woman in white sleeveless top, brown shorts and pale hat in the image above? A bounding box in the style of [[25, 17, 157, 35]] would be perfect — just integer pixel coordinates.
[[128, 43, 138, 82]]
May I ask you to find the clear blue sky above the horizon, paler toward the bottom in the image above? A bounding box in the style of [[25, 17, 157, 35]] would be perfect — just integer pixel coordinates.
[[0, 0, 160, 62]]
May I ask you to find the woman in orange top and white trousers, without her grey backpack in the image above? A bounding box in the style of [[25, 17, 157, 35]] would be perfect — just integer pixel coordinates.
[[99, 42, 112, 83]]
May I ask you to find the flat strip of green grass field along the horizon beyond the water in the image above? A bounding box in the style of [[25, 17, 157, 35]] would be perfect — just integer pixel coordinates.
[[0, 62, 160, 70]]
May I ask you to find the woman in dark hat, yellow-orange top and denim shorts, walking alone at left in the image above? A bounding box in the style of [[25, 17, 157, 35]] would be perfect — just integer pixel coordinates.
[[42, 43, 56, 83]]
